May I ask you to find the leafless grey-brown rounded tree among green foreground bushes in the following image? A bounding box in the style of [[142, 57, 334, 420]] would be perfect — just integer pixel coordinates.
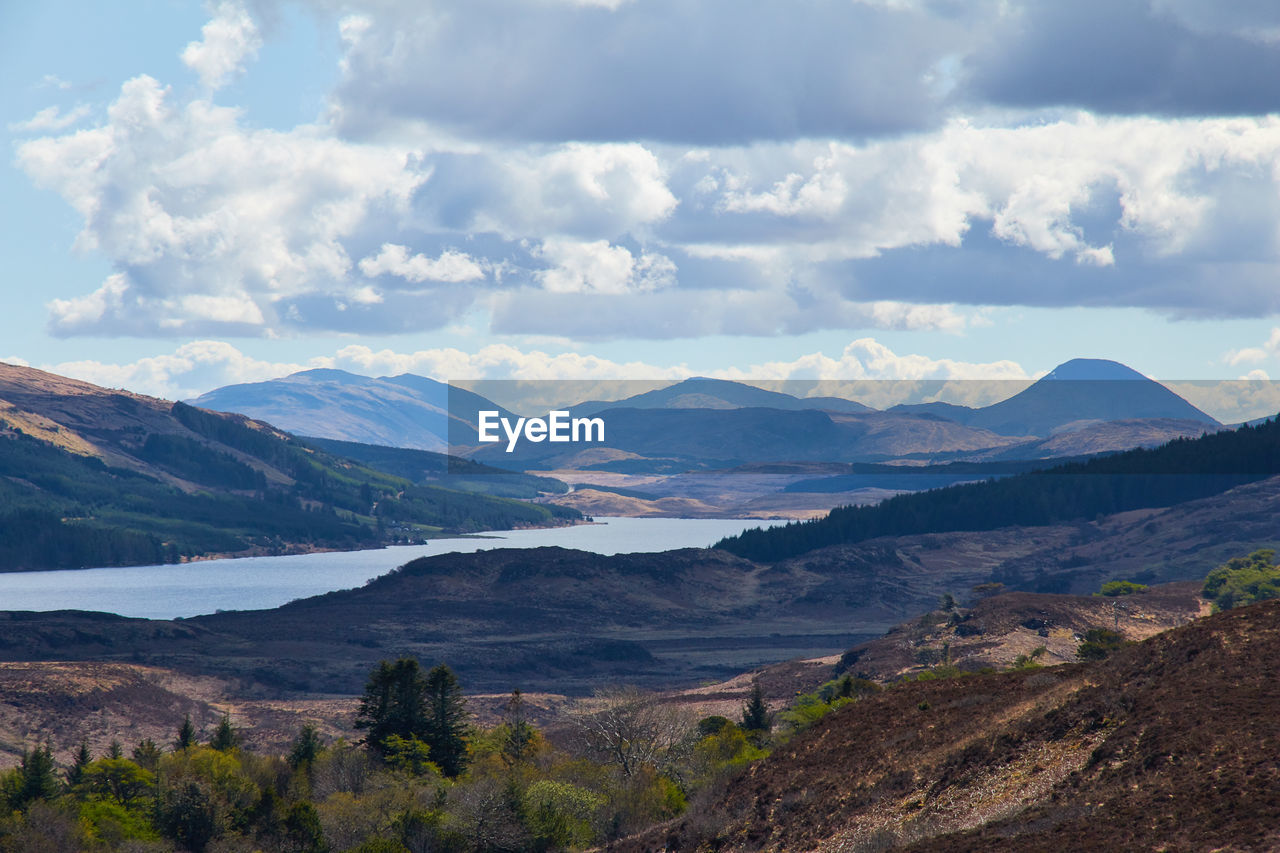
[[573, 686, 696, 777]]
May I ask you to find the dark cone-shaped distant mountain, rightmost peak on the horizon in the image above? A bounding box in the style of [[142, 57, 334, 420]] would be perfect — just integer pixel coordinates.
[[890, 359, 1220, 438]]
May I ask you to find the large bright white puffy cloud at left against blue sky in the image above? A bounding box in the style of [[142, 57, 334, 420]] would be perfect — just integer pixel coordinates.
[[18, 77, 424, 334]]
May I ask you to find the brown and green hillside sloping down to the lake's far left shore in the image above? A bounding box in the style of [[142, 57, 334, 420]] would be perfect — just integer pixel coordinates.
[[0, 364, 577, 571]]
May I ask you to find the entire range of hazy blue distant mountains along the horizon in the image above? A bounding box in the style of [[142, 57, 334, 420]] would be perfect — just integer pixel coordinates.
[[192, 359, 1220, 474]]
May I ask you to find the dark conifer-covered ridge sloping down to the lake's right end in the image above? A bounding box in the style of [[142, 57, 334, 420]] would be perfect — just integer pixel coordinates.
[[716, 412, 1280, 561]]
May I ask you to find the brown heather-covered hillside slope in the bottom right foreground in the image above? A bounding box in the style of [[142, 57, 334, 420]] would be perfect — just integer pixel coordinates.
[[614, 602, 1280, 852]]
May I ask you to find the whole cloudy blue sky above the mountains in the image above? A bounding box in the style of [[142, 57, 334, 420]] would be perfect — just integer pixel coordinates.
[[0, 0, 1280, 419]]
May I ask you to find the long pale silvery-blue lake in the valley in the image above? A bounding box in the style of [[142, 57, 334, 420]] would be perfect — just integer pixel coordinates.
[[0, 517, 785, 619]]
